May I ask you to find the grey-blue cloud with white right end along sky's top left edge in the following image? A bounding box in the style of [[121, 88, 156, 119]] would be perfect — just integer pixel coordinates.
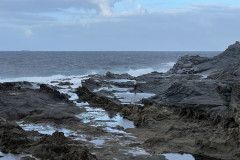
[[0, 0, 121, 13]]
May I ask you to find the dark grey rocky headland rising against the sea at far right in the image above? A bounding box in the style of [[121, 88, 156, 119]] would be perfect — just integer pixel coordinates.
[[168, 42, 240, 75]]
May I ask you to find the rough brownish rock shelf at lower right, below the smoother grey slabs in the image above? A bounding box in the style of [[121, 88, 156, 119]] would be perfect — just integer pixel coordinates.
[[123, 104, 239, 160]]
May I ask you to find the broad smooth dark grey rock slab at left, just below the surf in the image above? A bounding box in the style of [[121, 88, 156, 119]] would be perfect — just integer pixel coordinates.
[[0, 83, 81, 122]]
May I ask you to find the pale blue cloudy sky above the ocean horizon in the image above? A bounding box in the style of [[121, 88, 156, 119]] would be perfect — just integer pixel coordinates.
[[0, 0, 240, 51]]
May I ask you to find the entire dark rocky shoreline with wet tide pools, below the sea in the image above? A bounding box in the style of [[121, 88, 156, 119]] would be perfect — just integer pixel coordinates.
[[0, 42, 240, 160]]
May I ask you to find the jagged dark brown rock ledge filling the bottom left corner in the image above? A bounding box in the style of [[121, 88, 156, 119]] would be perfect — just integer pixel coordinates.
[[0, 120, 96, 160]]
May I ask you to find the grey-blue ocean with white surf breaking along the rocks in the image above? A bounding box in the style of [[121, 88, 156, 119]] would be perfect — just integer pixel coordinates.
[[0, 51, 220, 82]]
